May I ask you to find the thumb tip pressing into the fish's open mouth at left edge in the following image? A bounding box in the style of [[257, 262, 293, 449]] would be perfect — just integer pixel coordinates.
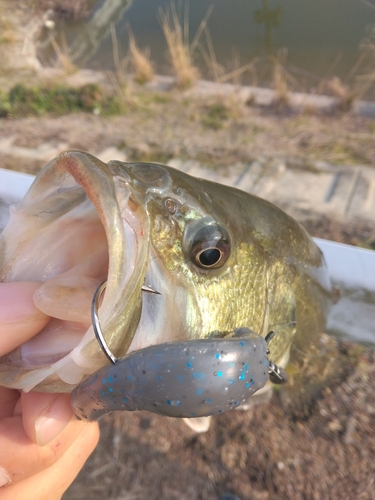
[[0, 282, 49, 356]]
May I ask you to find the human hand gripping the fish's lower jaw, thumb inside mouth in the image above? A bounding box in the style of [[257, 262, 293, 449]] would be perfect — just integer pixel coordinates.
[[0, 283, 99, 500]]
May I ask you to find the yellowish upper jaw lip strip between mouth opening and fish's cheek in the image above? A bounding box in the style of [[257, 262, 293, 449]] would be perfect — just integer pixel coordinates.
[[57, 151, 150, 356]]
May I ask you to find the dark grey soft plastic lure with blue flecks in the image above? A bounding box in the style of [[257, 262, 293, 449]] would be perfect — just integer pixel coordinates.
[[71, 328, 271, 421]]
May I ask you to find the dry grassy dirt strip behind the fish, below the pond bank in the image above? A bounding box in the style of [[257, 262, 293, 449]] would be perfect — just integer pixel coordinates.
[[0, 88, 375, 173]]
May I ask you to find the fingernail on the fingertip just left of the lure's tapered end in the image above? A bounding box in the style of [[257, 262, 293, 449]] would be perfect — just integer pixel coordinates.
[[35, 394, 73, 446]]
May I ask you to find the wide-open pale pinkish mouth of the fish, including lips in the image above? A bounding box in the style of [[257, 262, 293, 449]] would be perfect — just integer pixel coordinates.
[[0, 151, 150, 392]]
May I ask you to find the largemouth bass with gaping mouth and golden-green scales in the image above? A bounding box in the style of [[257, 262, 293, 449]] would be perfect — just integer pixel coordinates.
[[0, 151, 331, 418]]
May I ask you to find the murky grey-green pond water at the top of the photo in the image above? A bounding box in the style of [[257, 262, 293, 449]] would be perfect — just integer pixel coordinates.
[[40, 0, 375, 97]]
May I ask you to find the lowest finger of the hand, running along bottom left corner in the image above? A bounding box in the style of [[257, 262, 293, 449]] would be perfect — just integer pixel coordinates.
[[0, 424, 99, 500]]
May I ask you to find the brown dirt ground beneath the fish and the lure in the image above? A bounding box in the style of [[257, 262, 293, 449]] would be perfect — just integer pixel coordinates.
[[64, 342, 375, 500]]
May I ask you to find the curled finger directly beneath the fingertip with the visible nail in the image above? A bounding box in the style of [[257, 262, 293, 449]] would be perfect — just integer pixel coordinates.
[[0, 400, 95, 483]]
